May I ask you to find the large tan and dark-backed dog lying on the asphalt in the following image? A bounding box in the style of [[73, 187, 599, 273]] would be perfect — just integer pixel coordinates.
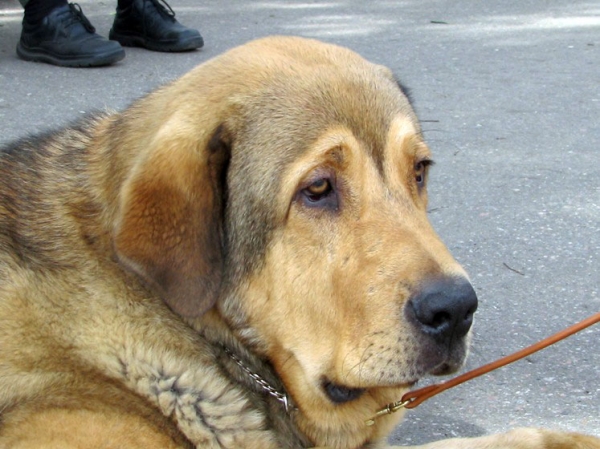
[[0, 37, 600, 449]]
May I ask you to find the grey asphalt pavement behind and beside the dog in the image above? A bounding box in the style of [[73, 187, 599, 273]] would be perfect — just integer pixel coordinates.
[[0, 0, 600, 444]]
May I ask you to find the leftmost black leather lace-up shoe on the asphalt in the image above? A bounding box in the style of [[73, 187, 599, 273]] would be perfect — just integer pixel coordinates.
[[17, 4, 125, 67]]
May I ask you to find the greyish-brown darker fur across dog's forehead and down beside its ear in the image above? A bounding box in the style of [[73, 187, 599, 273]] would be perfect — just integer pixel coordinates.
[[227, 66, 419, 280]]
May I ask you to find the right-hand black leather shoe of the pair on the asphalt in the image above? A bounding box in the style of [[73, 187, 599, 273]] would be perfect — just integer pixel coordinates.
[[108, 0, 204, 51]]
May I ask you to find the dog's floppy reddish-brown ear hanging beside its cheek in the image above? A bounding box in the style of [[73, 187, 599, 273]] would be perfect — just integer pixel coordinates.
[[114, 120, 230, 317]]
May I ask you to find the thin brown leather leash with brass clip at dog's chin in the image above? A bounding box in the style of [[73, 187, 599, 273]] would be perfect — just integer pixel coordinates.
[[365, 312, 600, 426]]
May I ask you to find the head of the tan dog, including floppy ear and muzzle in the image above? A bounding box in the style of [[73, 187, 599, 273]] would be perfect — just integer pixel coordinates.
[[115, 38, 477, 447]]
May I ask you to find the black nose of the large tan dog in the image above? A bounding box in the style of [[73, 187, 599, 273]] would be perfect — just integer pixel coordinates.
[[408, 277, 477, 344]]
